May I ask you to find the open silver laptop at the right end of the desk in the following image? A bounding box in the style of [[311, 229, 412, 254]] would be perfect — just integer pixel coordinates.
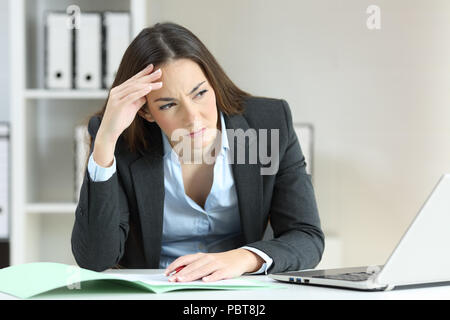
[[269, 174, 450, 291]]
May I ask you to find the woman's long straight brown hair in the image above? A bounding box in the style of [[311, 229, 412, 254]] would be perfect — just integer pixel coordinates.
[[90, 22, 251, 152]]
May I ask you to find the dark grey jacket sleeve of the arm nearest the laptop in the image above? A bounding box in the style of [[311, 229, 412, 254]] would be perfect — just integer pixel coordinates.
[[247, 100, 325, 273]]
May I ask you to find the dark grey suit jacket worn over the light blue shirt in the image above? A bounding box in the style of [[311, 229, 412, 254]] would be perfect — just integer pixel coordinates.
[[72, 97, 324, 273]]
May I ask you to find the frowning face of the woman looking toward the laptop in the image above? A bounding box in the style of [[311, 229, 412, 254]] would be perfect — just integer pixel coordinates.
[[140, 59, 220, 154]]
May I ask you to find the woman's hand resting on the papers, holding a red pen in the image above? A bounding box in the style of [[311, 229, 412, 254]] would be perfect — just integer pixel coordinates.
[[165, 248, 264, 282]]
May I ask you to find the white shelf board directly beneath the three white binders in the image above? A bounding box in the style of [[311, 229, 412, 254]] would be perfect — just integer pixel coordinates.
[[24, 89, 108, 99]]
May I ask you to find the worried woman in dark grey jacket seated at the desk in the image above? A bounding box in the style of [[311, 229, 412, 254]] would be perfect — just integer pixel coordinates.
[[72, 23, 324, 281]]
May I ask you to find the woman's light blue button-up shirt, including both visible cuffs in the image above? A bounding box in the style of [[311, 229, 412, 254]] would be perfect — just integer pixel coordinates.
[[88, 112, 273, 273]]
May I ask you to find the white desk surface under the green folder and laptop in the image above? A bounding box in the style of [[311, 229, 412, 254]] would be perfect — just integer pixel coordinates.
[[0, 269, 450, 300]]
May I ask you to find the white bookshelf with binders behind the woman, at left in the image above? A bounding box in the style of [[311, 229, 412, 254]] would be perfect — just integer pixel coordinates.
[[9, 0, 147, 265]]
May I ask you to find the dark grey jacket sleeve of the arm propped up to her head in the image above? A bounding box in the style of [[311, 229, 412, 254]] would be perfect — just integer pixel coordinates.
[[71, 117, 129, 271]]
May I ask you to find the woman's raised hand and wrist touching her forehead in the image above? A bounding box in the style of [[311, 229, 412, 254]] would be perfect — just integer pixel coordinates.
[[94, 64, 162, 167]]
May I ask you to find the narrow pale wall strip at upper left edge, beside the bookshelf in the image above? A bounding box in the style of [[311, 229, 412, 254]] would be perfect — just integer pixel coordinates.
[[0, 0, 10, 121]]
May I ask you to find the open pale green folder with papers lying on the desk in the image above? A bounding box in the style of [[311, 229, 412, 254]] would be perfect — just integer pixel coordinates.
[[0, 262, 283, 299]]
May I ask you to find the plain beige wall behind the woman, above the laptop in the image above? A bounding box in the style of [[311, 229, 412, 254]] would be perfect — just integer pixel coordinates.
[[148, 0, 450, 266]]
